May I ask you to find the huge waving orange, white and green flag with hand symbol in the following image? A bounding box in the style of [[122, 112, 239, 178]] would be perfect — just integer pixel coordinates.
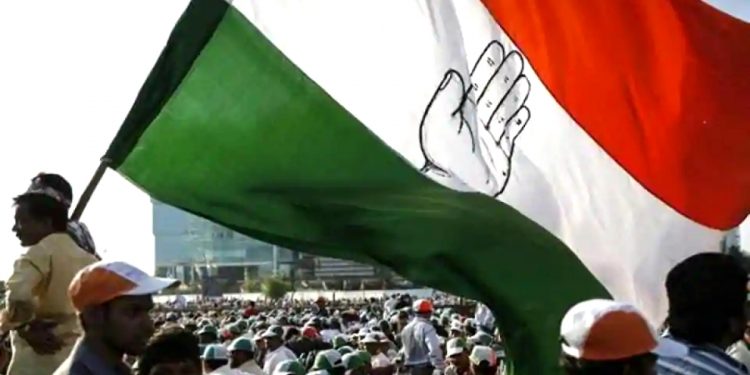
[[106, 0, 750, 375]]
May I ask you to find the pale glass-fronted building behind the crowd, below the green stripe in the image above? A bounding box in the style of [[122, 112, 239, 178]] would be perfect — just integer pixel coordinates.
[[153, 201, 401, 291]]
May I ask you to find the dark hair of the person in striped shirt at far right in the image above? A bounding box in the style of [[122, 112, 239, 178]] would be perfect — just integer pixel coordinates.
[[666, 253, 748, 345]]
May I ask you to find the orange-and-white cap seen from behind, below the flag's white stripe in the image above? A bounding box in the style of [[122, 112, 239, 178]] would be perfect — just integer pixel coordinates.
[[560, 299, 657, 361]]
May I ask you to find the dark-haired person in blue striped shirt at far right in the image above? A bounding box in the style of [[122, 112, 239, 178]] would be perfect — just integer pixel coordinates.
[[657, 253, 748, 375]]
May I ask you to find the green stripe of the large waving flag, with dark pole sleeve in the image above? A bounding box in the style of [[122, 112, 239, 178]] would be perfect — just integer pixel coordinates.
[[106, 0, 606, 375]]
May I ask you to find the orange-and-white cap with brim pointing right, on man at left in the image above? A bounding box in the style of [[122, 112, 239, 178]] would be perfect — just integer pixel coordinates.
[[68, 261, 180, 311]]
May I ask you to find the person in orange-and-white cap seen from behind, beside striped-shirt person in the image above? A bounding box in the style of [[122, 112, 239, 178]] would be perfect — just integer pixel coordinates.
[[560, 299, 657, 375]]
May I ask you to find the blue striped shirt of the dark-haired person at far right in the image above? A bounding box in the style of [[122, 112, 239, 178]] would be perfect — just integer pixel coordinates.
[[656, 335, 749, 375]]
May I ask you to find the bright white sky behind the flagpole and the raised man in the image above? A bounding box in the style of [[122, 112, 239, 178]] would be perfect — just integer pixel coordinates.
[[0, 0, 750, 279]]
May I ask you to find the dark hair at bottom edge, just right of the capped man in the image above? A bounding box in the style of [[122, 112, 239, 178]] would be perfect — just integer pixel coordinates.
[[138, 326, 201, 374]]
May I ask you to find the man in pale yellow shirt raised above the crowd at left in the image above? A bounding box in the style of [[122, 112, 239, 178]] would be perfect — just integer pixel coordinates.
[[0, 175, 97, 375]]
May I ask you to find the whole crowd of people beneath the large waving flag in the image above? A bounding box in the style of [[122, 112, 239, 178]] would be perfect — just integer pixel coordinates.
[[0, 174, 750, 375]]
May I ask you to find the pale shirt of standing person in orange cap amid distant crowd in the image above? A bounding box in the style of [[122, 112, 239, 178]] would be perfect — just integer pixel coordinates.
[[401, 317, 445, 369]]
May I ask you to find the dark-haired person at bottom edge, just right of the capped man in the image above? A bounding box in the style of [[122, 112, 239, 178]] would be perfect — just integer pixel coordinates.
[[138, 326, 202, 375]]
